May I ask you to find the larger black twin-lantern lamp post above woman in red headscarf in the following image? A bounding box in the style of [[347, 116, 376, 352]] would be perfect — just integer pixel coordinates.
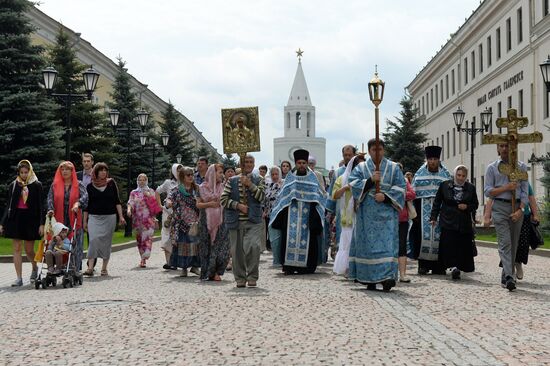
[[42, 65, 99, 160]]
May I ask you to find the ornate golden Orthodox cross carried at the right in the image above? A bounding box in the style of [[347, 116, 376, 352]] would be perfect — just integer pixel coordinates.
[[482, 108, 542, 212]]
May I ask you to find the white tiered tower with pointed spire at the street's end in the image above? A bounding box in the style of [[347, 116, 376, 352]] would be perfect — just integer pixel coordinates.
[[273, 58, 326, 170]]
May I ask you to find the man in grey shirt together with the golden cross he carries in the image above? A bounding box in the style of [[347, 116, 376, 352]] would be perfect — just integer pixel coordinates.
[[483, 109, 542, 291]]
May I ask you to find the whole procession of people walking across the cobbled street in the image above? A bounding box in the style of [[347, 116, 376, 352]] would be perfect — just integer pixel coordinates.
[[0, 139, 538, 291]]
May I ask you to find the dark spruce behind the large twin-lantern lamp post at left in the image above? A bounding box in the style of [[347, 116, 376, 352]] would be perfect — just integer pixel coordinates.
[[50, 28, 120, 171]]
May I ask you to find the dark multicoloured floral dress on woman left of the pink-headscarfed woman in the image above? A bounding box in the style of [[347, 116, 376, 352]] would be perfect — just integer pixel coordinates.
[[168, 189, 200, 269]]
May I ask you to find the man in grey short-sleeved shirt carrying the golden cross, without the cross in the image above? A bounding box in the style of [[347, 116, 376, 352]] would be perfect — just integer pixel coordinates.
[[484, 144, 529, 291]]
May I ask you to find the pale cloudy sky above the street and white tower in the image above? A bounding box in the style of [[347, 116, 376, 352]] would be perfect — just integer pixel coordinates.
[[39, 0, 480, 169]]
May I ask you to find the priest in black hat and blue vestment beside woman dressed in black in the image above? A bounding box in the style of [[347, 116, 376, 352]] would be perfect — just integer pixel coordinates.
[[409, 146, 452, 275]]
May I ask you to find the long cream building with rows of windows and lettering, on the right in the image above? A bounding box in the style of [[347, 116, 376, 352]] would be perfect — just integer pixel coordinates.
[[407, 0, 550, 202]]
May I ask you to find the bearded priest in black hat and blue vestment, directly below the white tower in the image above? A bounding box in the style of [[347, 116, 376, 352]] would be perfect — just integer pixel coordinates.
[[269, 149, 325, 275]]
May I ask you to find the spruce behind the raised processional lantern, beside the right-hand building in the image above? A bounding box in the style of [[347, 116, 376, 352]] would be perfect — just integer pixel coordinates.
[[383, 95, 427, 172]]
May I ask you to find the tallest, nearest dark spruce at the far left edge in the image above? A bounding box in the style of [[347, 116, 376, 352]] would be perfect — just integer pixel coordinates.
[[0, 0, 64, 206]]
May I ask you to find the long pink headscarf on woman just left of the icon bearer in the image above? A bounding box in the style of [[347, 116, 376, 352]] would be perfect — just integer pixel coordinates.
[[199, 164, 224, 243]]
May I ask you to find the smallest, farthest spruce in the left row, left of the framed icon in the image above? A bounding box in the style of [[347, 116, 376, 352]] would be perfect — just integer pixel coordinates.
[[159, 102, 195, 166]]
